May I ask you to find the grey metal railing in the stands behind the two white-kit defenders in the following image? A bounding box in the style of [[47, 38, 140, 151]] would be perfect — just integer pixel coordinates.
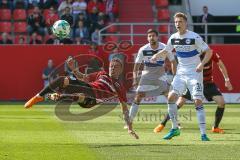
[[99, 22, 240, 44]]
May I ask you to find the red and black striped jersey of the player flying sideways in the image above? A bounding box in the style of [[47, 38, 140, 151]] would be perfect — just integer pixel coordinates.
[[87, 71, 127, 103]]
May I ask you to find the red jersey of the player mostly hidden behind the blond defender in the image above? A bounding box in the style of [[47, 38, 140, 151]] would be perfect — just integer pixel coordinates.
[[201, 52, 220, 83]]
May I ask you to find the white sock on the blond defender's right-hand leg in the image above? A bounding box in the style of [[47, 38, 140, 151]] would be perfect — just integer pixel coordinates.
[[196, 105, 206, 134]]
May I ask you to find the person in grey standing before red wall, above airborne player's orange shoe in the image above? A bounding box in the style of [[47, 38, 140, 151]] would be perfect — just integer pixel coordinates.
[[42, 59, 56, 87]]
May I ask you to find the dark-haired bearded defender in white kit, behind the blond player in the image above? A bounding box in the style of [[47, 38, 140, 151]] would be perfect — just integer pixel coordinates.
[[129, 29, 176, 125]]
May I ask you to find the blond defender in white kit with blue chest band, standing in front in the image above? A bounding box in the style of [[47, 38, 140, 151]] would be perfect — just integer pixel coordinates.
[[151, 12, 212, 141]]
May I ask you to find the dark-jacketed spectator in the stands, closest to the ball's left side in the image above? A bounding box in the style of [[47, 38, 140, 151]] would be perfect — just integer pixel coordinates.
[[27, 7, 45, 36]]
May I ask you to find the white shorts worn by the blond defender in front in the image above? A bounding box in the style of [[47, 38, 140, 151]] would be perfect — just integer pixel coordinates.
[[171, 72, 204, 100]]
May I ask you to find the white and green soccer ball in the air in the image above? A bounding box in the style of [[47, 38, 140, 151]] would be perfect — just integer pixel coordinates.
[[52, 20, 71, 39]]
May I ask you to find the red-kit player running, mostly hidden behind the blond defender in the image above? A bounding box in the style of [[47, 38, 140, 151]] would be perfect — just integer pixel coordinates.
[[154, 52, 233, 133]]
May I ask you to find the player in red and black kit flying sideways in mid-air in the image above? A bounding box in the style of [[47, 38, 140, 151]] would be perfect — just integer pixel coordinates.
[[25, 58, 138, 139]]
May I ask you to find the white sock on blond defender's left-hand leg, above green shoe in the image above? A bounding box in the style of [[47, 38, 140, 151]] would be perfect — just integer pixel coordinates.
[[168, 103, 178, 129]]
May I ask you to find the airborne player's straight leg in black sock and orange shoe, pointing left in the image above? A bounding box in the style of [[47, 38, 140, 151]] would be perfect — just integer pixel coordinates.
[[24, 77, 65, 108]]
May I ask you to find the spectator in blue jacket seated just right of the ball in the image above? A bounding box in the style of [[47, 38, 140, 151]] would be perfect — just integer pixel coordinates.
[[75, 21, 89, 43]]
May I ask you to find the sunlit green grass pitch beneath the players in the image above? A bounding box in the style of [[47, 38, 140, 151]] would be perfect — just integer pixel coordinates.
[[0, 103, 240, 160]]
